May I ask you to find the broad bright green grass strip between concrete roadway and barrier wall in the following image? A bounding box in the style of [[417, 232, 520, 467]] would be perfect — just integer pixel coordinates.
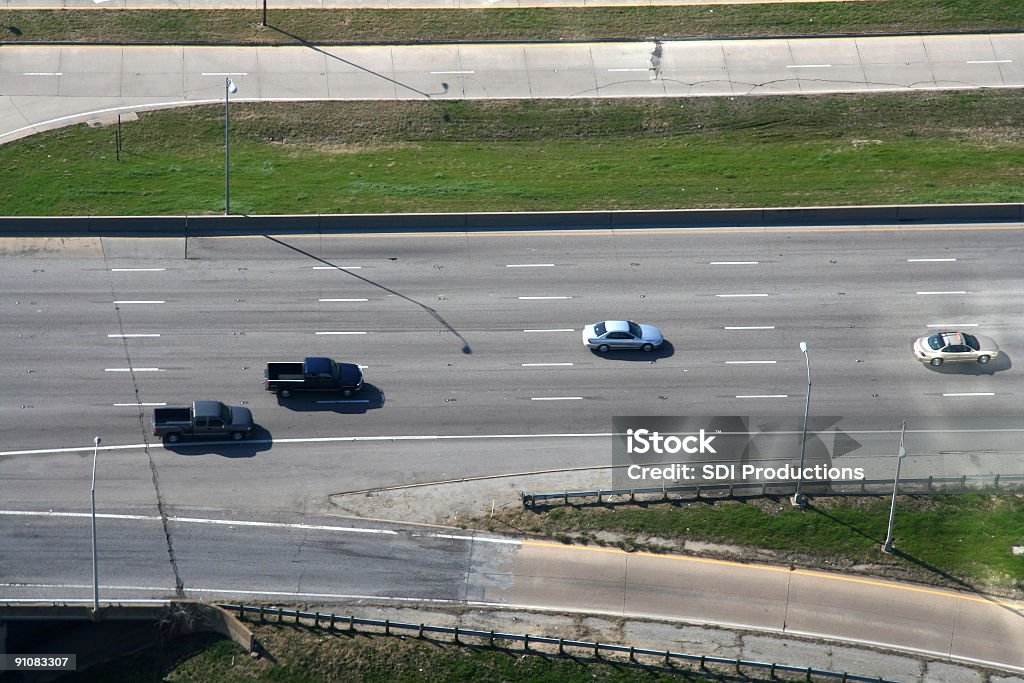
[[6, 91, 1024, 215]]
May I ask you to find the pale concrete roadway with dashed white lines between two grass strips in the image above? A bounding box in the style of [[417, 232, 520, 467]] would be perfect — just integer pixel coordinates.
[[0, 34, 1024, 143]]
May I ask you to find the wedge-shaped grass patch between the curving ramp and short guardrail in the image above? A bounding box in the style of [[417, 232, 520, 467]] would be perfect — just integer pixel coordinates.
[[507, 494, 1024, 593]]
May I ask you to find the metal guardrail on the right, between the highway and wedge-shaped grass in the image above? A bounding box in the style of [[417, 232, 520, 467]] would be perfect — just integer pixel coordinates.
[[519, 474, 1024, 508]]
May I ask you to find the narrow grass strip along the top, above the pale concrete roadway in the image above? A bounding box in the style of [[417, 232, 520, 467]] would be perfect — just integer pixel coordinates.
[[0, 0, 1024, 44]]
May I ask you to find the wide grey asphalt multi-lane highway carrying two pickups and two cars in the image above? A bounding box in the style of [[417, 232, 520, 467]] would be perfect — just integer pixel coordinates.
[[0, 226, 1024, 511]]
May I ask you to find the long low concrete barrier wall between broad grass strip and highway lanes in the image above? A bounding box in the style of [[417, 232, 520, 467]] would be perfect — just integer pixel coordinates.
[[0, 204, 1024, 237]]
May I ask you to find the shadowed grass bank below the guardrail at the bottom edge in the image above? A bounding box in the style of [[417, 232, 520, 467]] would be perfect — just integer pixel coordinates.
[[68, 623, 741, 683]]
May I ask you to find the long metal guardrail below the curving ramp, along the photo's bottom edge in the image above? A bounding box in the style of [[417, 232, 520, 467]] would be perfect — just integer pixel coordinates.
[[218, 603, 897, 683]]
